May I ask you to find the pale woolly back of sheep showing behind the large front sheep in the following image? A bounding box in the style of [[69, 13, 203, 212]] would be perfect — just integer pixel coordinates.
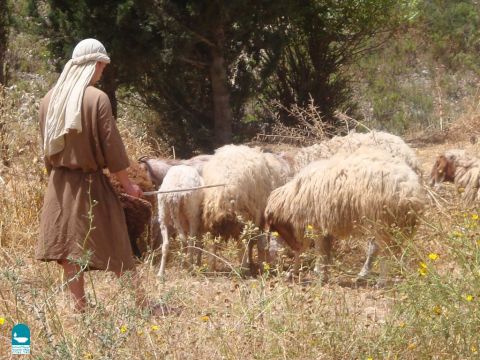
[[288, 131, 421, 174]]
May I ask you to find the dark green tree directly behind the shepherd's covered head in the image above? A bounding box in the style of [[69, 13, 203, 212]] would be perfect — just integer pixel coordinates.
[[30, 0, 158, 115]]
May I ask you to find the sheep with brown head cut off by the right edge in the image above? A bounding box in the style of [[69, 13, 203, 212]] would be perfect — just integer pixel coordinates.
[[430, 149, 480, 206]]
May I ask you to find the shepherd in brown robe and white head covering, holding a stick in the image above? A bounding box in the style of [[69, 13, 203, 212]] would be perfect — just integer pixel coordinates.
[[35, 39, 153, 311]]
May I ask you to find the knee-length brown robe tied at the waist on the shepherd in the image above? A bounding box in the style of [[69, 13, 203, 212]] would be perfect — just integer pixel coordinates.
[[35, 86, 134, 271]]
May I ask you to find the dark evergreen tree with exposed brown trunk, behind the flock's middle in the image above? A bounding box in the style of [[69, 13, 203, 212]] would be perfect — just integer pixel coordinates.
[[135, 0, 282, 146]]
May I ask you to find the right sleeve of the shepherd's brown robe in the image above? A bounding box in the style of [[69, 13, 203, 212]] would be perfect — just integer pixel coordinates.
[[97, 93, 130, 173]]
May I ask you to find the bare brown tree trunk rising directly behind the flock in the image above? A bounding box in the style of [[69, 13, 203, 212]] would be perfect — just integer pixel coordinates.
[[210, 29, 233, 146]]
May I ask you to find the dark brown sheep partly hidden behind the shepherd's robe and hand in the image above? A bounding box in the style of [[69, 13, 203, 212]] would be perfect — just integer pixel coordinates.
[[105, 161, 154, 257]]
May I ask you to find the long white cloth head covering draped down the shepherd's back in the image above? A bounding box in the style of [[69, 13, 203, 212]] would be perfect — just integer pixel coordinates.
[[43, 39, 110, 156]]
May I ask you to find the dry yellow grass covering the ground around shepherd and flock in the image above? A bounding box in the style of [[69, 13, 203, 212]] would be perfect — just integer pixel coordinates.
[[0, 83, 480, 359]]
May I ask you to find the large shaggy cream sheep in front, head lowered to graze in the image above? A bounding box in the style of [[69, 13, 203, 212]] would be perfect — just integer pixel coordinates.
[[265, 147, 425, 281]]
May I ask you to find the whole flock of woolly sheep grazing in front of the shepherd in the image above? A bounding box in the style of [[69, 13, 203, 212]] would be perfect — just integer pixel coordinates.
[[115, 131, 480, 282]]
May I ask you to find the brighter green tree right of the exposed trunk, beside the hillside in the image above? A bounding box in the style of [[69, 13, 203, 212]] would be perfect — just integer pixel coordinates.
[[260, 0, 410, 125]]
